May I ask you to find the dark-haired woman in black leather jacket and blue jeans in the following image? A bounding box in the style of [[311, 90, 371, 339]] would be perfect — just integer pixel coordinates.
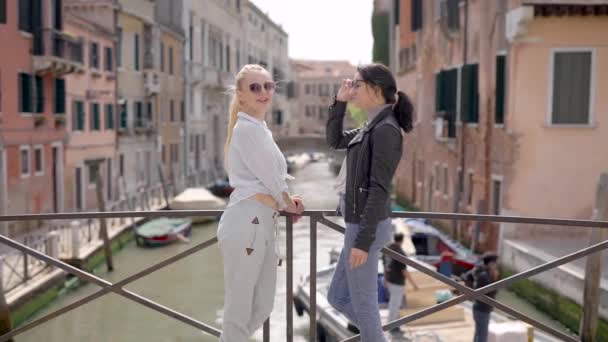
[[326, 64, 413, 342]]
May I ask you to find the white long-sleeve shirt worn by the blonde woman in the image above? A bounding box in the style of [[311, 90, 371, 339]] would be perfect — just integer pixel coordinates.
[[227, 112, 293, 209]]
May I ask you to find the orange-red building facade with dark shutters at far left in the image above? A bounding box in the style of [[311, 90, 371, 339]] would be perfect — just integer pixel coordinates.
[[0, 0, 83, 236]]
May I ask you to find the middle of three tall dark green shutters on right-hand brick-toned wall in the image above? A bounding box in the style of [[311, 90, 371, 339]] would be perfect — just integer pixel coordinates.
[[460, 64, 479, 123]]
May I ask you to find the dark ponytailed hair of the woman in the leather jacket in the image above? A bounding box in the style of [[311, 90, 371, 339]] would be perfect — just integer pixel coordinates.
[[357, 63, 414, 133]]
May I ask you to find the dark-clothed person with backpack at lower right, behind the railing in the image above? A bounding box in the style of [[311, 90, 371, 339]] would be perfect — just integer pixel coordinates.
[[472, 253, 499, 342]]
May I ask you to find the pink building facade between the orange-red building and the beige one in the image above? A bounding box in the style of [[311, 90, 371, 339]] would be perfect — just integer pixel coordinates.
[[64, 0, 118, 211]]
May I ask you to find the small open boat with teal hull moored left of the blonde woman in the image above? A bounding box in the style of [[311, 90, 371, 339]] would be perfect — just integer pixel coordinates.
[[135, 217, 192, 247]]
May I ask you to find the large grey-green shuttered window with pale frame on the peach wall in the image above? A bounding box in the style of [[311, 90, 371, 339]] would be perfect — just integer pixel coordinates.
[[551, 51, 593, 125]]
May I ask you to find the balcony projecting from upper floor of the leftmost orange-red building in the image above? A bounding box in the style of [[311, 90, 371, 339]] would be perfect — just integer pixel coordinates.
[[33, 29, 84, 76]]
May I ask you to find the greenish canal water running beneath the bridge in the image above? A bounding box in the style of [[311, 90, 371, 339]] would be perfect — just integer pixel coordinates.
[[16, 162, 568, 342]]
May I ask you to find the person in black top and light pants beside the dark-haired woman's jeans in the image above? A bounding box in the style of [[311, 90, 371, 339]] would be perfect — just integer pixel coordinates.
[[383, 233, 418, 335]]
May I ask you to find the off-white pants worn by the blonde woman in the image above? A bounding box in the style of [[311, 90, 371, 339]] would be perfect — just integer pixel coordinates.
[[217, 200, 279, 342]]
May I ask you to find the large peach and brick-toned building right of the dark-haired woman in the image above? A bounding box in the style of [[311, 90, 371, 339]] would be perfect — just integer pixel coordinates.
[[397, 0, 608, 251]]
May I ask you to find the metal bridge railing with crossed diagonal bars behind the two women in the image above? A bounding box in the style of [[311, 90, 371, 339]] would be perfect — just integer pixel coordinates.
[[0, 210, 608, 342]]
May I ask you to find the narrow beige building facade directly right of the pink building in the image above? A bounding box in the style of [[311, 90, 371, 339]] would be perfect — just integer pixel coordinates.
[[116, 0, 161, 193]]
